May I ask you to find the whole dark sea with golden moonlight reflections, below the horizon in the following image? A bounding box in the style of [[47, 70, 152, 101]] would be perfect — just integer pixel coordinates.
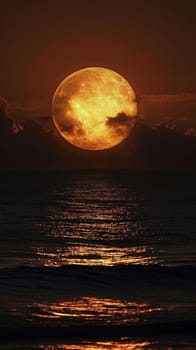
[[0, 171, 196, 350]]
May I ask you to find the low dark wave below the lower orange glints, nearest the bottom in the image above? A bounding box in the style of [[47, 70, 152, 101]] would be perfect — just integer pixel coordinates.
[[0, 320, 196, 341]]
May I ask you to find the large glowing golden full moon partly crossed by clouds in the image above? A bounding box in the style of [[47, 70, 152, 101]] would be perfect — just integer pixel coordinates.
[[52, 67, 137, 150]]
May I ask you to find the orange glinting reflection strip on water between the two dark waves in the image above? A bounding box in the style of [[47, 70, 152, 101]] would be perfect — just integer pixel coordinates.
[[32, 297, 161, 325]]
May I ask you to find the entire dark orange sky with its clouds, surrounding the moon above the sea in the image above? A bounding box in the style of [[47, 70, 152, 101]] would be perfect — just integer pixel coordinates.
[[0, 0, 196, 168]]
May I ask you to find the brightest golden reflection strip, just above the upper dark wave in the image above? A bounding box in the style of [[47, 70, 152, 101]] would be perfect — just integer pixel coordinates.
[[36, 243, 155, 267]]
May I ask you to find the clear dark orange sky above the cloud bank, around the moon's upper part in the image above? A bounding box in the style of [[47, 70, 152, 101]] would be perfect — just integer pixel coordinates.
[[0, 0, 196, 146]]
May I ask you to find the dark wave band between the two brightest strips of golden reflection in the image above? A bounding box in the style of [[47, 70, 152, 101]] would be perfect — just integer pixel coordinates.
[[0, 264, 196, 286]]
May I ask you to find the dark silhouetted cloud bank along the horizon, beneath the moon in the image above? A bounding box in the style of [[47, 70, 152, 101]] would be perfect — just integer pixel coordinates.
[[0, 98, 196, 169]]
